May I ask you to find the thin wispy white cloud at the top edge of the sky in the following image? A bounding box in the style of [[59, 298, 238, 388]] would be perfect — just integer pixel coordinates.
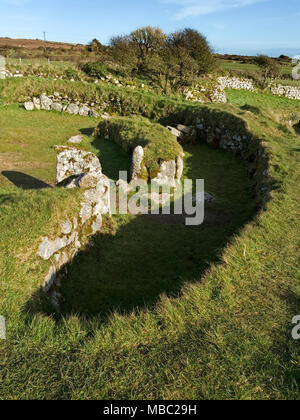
[[166, 0, 270, 20]]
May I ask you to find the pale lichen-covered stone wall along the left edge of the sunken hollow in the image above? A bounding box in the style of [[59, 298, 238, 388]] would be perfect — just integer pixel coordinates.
[[38, 146, 110, 307]]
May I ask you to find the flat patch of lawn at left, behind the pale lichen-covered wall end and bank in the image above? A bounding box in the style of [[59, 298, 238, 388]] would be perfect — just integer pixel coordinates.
[[0, 105, 130, 188]]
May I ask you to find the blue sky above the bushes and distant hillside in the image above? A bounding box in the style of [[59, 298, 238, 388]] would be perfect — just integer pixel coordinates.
[[0, 0, 300, 56]]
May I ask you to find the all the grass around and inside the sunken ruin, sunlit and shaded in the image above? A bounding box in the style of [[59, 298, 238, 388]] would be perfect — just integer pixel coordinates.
[[0, 83, 300, 400]]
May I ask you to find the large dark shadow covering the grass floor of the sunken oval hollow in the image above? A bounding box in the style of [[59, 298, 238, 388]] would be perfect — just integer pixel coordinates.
[[26, 140, 255, 319]]
